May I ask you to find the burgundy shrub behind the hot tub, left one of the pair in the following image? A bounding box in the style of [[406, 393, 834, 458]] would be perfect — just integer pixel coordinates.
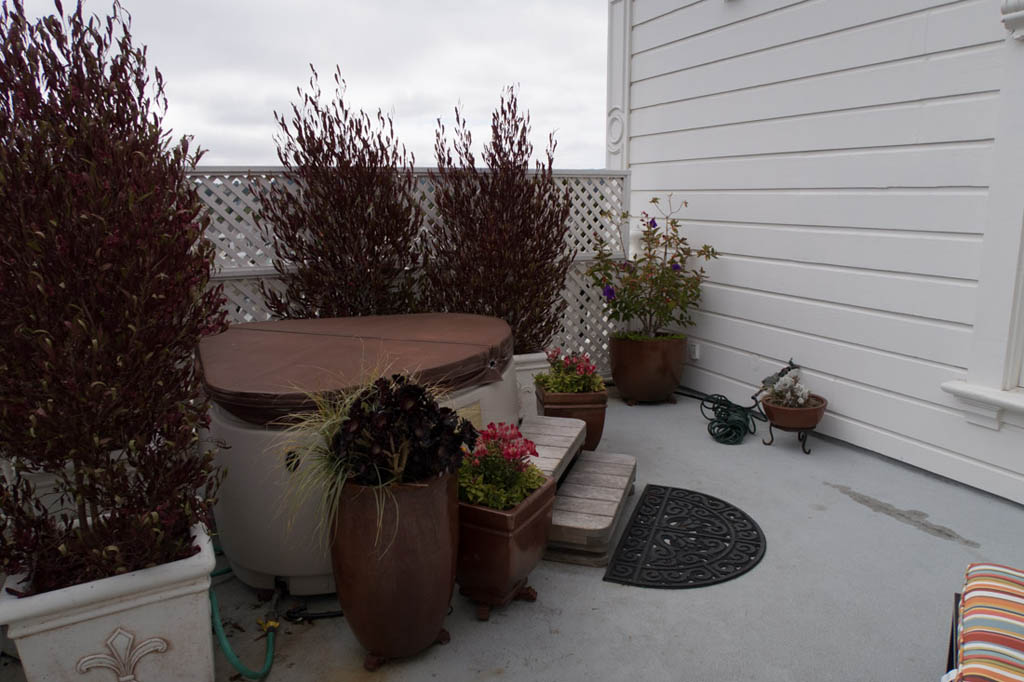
[[253, 66, 423, 317]]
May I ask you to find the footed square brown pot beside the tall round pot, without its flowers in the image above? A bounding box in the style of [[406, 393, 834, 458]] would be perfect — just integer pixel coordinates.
[[458, 478, 555, 621]]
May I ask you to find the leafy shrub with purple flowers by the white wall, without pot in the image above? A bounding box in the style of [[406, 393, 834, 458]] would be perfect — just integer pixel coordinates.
[[587, 195, 718, 339]]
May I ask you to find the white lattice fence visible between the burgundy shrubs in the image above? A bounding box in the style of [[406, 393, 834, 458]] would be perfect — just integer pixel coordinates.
[[189, 167, 630, 369]]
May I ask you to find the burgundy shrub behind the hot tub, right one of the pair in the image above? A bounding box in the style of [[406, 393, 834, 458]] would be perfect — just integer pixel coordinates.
[[424, 87, 574, 353]]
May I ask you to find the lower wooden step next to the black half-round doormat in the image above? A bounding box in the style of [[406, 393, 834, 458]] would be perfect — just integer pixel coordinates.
[[544, 452, 637, 566]]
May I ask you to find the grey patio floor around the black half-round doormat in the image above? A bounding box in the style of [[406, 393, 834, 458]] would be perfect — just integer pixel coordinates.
[[0, 398, 1024, 682]]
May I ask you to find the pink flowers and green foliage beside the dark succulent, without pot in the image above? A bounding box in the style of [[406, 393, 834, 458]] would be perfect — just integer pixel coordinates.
[[459, 422, 546, 510]]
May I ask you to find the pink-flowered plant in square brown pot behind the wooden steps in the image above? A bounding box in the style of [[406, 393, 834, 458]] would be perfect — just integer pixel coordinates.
[[534, 348, 608, 450]]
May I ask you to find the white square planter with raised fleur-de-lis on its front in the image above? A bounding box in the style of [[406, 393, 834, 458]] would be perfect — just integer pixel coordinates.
[[0, 526, 216, 682]]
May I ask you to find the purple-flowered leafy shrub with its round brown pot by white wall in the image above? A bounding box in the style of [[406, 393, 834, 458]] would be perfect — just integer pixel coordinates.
[[587, 195, 718, 403]]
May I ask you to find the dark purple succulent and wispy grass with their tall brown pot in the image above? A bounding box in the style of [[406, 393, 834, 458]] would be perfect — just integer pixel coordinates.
[[285, 375, 477, 670]]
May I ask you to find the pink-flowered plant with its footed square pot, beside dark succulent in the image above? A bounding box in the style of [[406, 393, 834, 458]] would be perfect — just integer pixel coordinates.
[[458, 424, 555, 621]]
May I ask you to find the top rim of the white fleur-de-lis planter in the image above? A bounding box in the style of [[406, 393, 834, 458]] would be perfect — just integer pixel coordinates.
[[0, 524, 217, 630]]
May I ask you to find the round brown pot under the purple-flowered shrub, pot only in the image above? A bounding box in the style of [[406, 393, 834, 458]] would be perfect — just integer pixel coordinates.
[[610, 337, 686, 402]]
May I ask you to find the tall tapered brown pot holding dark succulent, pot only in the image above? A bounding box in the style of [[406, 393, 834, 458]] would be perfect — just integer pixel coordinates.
[[331, 474, 459, 670]]
